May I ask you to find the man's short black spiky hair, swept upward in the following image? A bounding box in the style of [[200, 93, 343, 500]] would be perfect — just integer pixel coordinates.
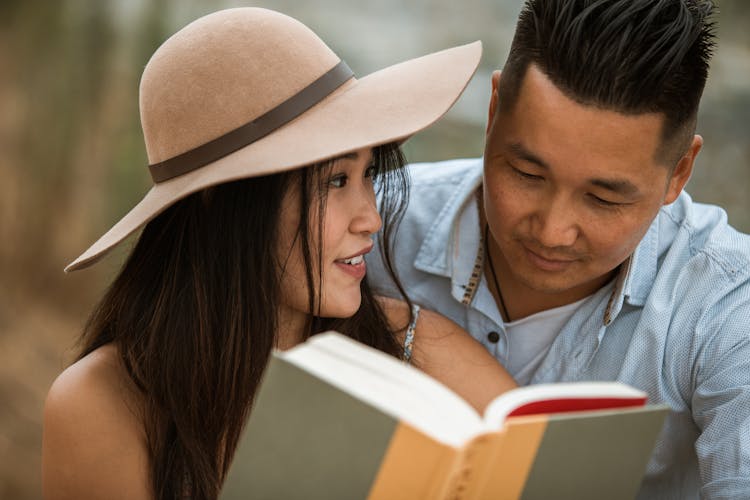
[[500, 0, 716, 166]]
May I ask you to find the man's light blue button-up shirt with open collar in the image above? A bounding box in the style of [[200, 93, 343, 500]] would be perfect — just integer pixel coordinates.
[[367, 159, 750, 499]]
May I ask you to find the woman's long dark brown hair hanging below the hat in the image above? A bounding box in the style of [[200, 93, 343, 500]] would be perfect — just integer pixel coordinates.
[[79, 145, 408, 499]]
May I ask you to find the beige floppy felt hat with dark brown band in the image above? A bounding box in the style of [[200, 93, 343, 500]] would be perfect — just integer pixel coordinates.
[[65, 8, 482, 272]]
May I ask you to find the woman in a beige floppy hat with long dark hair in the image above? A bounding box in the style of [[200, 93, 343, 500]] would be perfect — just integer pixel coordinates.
[[43, 8, 512, 498]]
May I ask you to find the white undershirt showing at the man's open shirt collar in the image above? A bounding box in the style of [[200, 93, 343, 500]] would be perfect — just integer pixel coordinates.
[[505, 297, 588, 385]]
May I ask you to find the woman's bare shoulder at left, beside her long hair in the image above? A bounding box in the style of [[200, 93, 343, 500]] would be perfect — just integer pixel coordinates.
[[42, 345, 150, 499]]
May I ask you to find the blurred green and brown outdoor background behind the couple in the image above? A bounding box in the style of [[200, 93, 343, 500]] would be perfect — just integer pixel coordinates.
[[0, 0, 750, 499]]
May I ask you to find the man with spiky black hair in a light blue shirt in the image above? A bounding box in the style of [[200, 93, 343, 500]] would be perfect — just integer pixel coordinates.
[[368, 0, 750, 499]]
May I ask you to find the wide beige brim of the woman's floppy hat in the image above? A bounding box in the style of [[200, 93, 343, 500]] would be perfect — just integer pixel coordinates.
[[65, 41, 482, 272]]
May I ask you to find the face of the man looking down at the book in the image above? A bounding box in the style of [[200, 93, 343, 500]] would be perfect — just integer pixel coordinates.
[[484, 65, 700, 301]]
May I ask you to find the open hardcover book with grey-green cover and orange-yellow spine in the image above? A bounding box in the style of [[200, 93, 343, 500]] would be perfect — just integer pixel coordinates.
[[220, 333, 668, 500]]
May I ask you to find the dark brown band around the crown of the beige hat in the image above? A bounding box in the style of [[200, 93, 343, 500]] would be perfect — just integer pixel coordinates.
[[148, 61, 354, 183]]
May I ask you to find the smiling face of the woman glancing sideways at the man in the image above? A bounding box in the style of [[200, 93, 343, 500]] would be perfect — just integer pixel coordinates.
[[279, 148, 382, 329]]
